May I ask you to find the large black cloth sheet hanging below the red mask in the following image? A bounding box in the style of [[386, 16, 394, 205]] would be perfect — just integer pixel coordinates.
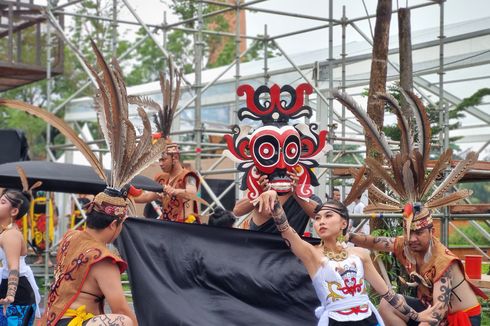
[[116, 218, 320, 326]]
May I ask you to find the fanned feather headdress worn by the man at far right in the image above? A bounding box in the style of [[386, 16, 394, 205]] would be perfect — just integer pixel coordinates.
[[333, 89, 477, 238]]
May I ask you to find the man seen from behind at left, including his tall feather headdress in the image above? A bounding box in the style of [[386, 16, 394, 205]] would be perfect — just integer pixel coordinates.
[[0, 42, 170, 326]]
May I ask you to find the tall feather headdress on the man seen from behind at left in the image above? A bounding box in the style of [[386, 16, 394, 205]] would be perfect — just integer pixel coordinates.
[[0, 41, 166, 217]]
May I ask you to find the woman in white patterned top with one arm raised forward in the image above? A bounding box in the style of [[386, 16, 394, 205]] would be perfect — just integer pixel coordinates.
[[255, 190, 437, 326]]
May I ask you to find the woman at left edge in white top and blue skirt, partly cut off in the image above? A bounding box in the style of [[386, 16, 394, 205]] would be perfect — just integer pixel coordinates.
[[0, 168, 41, 325]]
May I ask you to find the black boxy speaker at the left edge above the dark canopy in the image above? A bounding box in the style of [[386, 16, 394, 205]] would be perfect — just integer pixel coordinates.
[[0, 129, 29, 164]]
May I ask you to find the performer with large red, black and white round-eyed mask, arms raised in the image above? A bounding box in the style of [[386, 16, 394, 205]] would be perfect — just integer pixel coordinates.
[[225, 84, 330, 234]]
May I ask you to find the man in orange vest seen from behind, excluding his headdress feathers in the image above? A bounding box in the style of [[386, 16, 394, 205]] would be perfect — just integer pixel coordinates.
[[41, 189, 138, 326]]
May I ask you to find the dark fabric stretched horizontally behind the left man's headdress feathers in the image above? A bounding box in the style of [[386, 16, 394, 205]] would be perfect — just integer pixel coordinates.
[[0, 161, 162, 194]]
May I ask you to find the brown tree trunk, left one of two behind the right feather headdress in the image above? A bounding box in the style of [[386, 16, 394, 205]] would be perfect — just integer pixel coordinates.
[[366, 0, 392, 229]]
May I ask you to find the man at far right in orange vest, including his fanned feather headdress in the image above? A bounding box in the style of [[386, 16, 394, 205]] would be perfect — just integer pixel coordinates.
[[333, 89, 486, 325]]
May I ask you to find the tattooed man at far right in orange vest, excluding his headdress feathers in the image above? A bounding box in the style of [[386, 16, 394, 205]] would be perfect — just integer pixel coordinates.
[[347, 206, 486, 325]]
